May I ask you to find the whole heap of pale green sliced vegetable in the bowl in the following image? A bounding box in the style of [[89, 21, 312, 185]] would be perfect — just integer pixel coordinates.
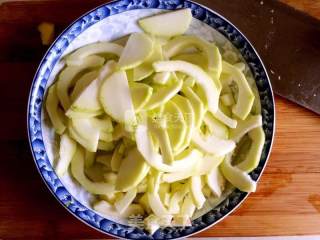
[[46, 9, 265, 233]]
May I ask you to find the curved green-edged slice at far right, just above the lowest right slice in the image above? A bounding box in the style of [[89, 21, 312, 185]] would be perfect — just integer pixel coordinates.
[[237, 127, 265, 172]]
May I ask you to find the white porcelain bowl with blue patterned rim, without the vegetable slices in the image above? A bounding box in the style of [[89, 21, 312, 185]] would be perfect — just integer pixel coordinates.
[[28, 1, 274, 238]]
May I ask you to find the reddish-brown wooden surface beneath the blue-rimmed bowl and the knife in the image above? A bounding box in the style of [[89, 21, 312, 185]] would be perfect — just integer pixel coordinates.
[[0, 0, 320, 239]]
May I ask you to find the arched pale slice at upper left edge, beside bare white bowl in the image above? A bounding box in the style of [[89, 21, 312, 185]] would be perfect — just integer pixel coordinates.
[[66, 42, 123, 66]]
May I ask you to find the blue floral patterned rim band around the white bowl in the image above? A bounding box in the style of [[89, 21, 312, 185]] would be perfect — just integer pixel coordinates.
[[27, 0, 275, 239]]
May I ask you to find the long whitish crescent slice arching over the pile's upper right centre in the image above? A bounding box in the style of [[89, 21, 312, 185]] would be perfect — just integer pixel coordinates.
[[153, 61, 220, 113]]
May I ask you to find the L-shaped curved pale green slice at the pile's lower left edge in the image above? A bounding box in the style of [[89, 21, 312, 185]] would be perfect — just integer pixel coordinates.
[[71, 148, 114, 194]]
